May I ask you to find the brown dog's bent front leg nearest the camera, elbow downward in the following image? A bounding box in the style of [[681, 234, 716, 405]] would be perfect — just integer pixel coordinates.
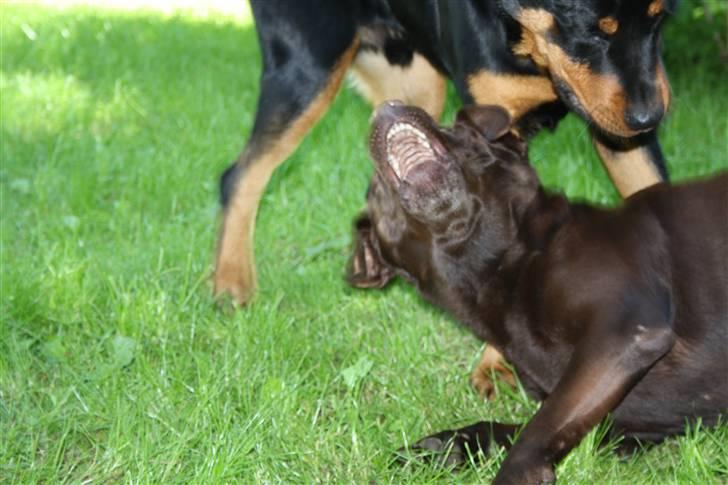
[[494, 324, 675, 485]]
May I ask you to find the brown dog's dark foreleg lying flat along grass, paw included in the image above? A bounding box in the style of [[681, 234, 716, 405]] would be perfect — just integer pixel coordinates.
[[400, 421, 520, 467]]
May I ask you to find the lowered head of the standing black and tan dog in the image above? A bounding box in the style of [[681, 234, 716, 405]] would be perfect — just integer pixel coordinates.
[[502, 0, 676, 137]]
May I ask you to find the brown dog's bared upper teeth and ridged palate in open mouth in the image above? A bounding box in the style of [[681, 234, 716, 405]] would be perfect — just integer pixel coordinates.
[[387, 123, 433, 180]]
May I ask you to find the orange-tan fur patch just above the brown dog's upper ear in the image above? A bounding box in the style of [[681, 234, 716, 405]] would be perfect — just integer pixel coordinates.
[[467, 70, 557, 119]]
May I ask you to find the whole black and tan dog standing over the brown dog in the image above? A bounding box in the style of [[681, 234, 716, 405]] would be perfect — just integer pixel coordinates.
[[214, 0, 676, 304]]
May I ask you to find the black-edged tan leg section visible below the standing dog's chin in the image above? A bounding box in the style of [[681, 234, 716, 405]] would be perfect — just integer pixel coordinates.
[[592, 131, 669, 197]]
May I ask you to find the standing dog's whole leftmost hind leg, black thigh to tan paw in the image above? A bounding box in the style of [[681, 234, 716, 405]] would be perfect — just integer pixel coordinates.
[[214, 0, 357, 304]]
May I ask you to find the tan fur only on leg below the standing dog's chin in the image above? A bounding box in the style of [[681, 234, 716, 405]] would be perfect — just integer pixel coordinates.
[[594, 140, 662, 197]]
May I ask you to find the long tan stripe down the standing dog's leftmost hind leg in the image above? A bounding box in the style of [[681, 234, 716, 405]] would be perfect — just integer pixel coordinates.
[[215, 42, 357, 305]]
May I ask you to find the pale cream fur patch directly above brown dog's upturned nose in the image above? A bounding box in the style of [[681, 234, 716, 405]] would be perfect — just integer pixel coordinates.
[[351, 51, 445, 120]]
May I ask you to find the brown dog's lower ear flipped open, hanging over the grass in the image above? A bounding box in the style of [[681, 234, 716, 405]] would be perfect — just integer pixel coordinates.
[[346, 213, 395, 288]]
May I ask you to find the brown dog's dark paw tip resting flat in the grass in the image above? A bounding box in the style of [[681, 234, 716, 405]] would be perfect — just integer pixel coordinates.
[[397, 428, 487, 468]]
